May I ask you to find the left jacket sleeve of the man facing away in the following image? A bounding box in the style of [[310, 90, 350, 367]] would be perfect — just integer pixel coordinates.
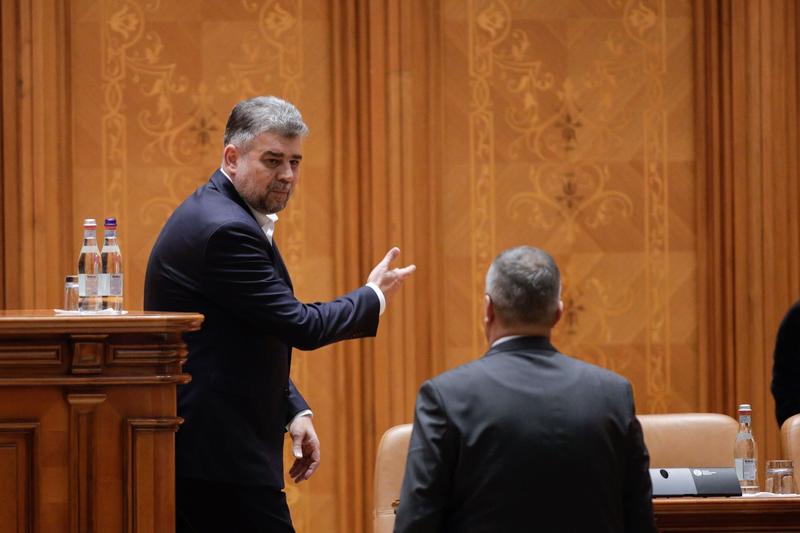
[[394, 381, 458, 533]]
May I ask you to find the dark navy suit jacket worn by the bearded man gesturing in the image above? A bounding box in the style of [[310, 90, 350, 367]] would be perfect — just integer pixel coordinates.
[[144, 171, 380, 487]]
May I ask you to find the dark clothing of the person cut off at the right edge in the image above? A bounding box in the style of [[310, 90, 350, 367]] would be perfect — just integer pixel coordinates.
[[772, 301, 800, 426]]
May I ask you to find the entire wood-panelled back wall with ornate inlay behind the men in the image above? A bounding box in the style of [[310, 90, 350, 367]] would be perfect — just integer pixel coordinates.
[[0, 0, 800, 533]]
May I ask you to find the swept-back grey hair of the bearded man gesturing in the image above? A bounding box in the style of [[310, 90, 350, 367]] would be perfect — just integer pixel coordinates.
[[224, 96, 308, 150]]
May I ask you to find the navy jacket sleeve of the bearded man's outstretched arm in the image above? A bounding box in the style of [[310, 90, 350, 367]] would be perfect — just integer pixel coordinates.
[[202, 224, 380, 350]]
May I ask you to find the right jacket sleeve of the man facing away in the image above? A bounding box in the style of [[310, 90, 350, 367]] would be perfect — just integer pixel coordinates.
[[623, 383, 658, 533]]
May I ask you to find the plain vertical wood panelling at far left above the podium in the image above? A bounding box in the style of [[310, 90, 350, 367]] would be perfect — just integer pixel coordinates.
[[0, 0, 77, 309]]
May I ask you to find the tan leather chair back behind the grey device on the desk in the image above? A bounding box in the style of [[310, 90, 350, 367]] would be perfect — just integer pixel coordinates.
[[638, 413, 739, 468]]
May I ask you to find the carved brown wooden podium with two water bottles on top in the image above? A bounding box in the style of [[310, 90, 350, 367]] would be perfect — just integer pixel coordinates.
[[0, 311, 203, 533]]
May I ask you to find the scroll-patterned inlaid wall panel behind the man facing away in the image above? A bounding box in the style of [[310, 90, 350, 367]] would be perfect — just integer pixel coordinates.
[[444, 0, 699, 412]]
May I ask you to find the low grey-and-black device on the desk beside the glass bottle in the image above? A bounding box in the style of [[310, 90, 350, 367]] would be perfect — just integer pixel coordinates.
[[650, 468, 742, 497]]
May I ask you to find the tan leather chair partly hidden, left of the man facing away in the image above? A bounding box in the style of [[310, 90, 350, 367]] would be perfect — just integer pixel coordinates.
[[373, 424, 411, 533]]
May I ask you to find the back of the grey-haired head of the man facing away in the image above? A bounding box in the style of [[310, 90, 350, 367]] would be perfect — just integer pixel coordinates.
[[486, 246, 561, 327]]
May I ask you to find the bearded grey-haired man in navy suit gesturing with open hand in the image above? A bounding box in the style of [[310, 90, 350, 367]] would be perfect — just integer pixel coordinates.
[[144, 97, 414, 533]]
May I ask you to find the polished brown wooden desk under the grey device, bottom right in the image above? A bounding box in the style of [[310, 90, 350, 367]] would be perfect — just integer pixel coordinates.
[[653, 497, 800, 533]]
